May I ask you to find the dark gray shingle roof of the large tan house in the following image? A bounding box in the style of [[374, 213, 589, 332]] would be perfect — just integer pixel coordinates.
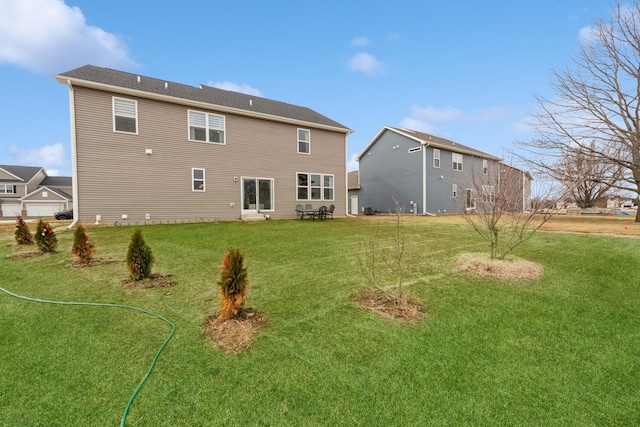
[[56, 65, 350, 132]]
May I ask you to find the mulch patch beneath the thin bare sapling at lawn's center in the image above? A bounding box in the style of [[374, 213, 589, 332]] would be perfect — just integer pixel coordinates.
[[355, 289, 425, 323]]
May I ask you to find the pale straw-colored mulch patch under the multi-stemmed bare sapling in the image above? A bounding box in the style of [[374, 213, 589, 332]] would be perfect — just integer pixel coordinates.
[[457, 253, 544, 282]]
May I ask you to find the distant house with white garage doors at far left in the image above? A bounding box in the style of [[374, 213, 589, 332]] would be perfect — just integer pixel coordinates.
[[0, 165, 73, 218]]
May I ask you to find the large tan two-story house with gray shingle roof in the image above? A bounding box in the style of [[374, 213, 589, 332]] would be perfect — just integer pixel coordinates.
[[55, 65, 352, 223]]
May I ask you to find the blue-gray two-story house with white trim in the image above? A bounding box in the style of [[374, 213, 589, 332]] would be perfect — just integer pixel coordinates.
[[356, 126, 531, 215]]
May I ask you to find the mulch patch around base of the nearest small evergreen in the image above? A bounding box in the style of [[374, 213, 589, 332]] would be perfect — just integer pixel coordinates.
[[202, 308, 266, 354]]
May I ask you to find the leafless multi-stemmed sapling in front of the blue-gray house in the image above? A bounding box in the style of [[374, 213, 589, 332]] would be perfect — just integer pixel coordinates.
[[458, 163, 555, 260]]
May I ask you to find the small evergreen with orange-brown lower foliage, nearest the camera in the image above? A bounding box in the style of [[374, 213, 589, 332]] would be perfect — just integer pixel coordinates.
[[214, 248, 249, 324]]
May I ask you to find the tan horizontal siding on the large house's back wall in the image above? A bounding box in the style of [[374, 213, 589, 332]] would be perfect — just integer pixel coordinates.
[[73, 86, 346, 222]]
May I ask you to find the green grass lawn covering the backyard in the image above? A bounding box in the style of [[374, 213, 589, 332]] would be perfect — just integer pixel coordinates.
[[0, 217, 640, 426]]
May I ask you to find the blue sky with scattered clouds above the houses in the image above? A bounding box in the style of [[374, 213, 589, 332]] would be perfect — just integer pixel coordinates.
[[0, 0, 613, 175]]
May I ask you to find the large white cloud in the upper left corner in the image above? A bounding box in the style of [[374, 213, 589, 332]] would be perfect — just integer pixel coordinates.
[[0, 0, 137, 74]]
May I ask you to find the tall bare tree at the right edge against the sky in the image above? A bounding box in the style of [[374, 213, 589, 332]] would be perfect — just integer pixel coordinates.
[[518, 1, 640, 222]]
